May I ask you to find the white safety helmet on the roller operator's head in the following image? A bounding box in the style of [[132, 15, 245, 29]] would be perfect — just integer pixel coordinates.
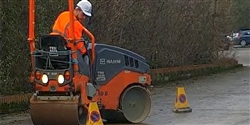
[[77, 0, 92, 17]]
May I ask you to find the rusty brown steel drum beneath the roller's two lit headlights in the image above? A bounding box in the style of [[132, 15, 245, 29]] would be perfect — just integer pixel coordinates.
[[30, 96, 86, 125]]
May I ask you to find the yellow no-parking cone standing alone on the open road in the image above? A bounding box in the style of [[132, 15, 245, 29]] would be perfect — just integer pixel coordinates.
[[173, 87, 192, 113]]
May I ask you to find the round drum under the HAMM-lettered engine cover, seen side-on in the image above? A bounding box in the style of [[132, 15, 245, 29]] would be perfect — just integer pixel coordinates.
[[120, 86, 151, 123]]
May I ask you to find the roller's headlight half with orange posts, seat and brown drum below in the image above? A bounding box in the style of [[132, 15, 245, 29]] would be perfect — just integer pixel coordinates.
[[27, 0, 95, 125]]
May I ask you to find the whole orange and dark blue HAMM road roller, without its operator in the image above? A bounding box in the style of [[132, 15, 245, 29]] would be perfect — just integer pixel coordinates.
[[27, 0, 151, 125]]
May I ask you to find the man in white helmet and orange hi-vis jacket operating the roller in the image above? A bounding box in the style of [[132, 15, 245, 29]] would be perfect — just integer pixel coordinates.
[[50, 0, 92, 75]]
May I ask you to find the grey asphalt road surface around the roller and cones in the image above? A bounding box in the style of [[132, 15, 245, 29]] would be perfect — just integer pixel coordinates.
[[0, 48, 250, 125]]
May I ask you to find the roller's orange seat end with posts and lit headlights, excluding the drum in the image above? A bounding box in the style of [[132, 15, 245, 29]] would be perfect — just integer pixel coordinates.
[[28, 0, 95, 103]]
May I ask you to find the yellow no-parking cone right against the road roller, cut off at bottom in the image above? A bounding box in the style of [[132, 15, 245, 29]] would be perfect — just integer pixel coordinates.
[[86, 101, 103, 125]]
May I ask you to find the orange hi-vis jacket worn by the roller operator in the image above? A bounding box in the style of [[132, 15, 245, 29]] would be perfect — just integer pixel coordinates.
[[50, 11, 86, 54]]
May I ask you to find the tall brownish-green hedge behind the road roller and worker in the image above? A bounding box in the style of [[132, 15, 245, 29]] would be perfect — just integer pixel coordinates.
[[0, 0, 250, 95]]
